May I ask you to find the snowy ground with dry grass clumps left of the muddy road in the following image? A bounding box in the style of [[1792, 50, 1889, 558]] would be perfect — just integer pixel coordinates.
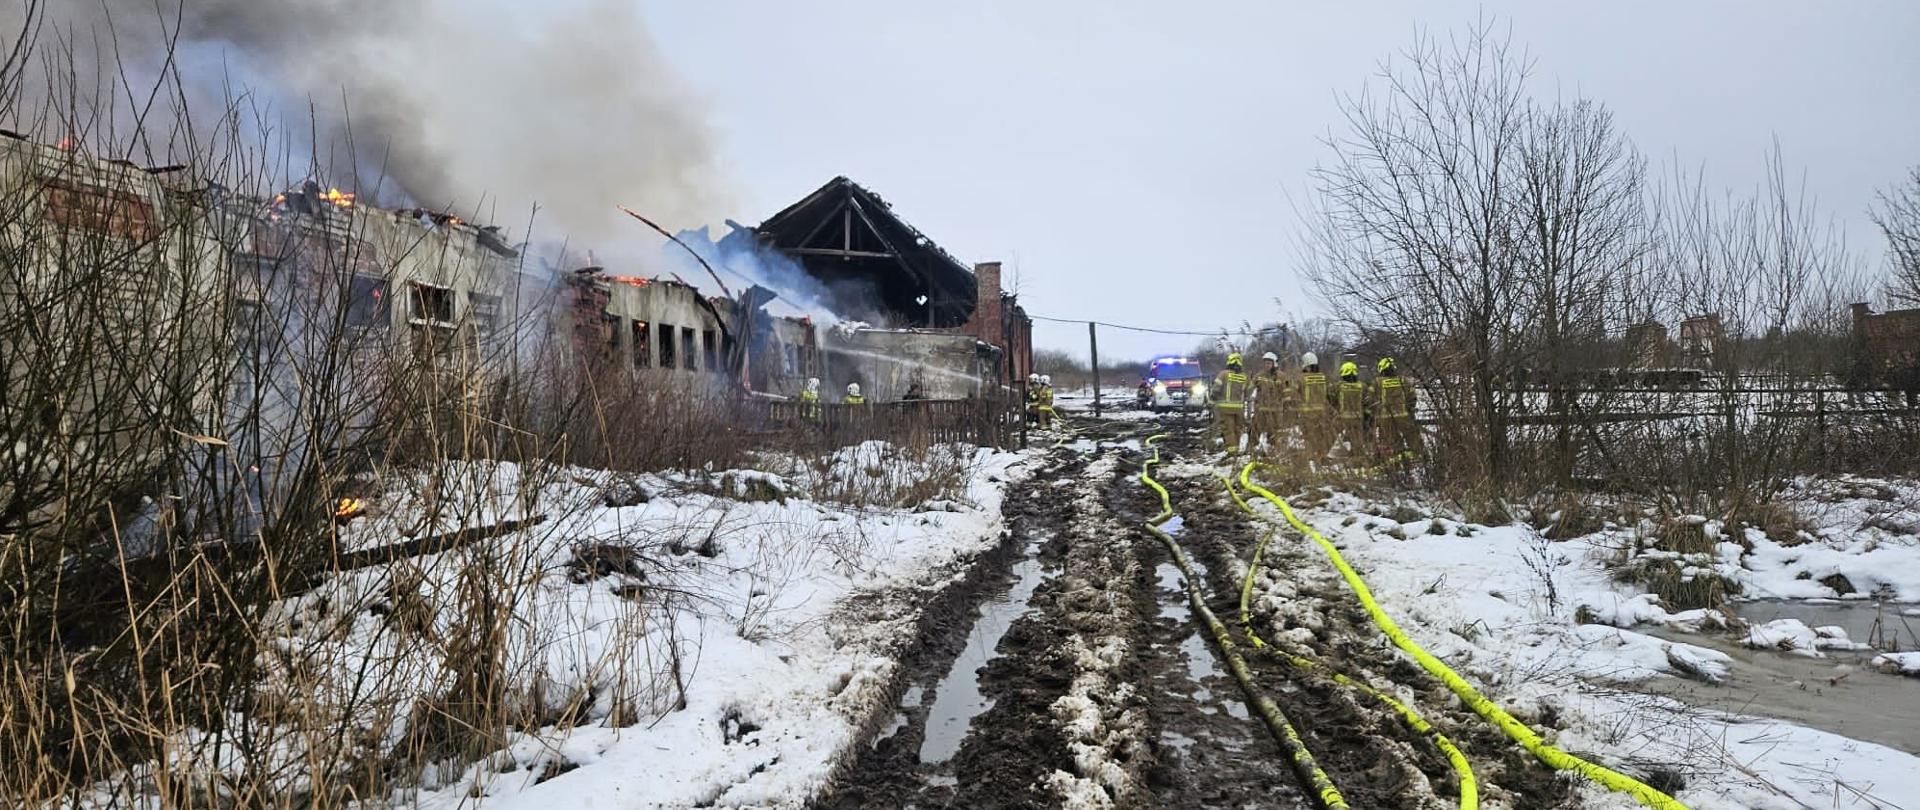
[[106, 443, 1035, 810]]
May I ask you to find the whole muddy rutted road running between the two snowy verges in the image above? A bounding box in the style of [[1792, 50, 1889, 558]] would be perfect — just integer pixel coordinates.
[[812, 418, 1571, 808]]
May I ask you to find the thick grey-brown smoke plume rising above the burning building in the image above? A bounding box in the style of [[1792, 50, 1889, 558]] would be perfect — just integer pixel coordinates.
[[0, 0, 730, 247]]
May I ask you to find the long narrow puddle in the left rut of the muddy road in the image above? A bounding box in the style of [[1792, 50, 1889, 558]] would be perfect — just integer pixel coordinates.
[[920, 539, 1046, 764]]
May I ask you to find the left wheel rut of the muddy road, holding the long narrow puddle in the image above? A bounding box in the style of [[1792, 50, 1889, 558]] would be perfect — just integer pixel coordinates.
[[810, 422, 1144, 808]]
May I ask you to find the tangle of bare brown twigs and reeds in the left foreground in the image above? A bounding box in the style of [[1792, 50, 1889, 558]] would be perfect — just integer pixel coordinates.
[[0, 8, 718, 808]]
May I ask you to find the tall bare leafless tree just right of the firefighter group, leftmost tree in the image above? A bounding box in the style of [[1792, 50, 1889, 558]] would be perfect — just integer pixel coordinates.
[[1308, 23, 1530, 484]]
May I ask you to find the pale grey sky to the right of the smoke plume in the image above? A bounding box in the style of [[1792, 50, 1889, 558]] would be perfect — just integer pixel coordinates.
[[643, 0, 1920, 357]]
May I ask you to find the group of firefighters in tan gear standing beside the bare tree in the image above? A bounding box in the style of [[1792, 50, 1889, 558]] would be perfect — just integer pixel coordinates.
[[1212, 351, 1423, 459]]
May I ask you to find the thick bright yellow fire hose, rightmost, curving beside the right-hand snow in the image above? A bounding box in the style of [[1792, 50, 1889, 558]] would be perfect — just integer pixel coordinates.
[[1240, 463, 1688, 810]]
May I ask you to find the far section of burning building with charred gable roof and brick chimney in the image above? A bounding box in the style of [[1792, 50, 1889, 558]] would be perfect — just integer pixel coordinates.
[[570, 177, 1033, 401]]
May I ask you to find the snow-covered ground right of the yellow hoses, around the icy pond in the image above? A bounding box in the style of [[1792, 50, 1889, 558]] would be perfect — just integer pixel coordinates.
[[1258, 482, 1920, 810]]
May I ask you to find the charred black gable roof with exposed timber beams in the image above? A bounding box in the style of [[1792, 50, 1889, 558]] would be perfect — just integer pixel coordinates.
[[755, 177, 977, 326]]
